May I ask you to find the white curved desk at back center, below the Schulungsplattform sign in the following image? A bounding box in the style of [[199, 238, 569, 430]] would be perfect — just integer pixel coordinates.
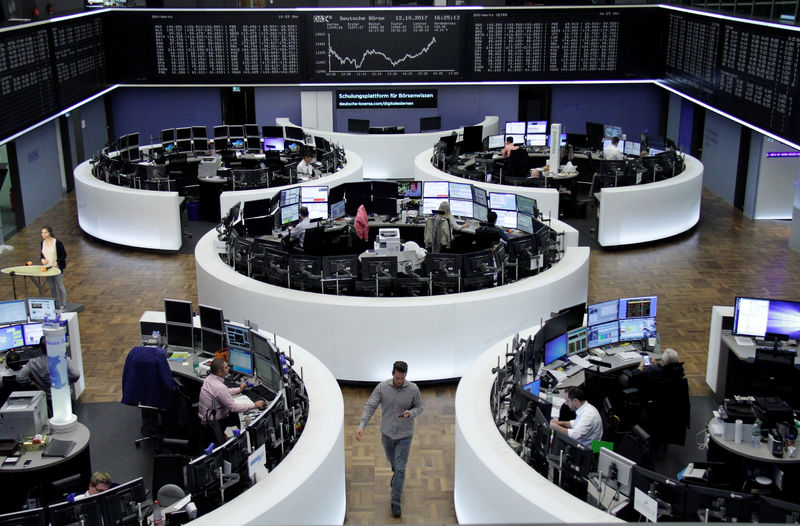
[[275, 116, 499, 179]]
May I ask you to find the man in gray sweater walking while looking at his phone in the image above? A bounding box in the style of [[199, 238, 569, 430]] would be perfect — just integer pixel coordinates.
[[356, 361, 422, 517]]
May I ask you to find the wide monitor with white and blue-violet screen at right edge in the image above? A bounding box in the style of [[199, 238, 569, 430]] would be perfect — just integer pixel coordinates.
[[733, 297, 800, 339]]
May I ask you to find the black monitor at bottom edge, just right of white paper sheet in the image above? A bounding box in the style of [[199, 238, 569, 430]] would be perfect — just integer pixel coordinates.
[[684, 484, 760, 523]]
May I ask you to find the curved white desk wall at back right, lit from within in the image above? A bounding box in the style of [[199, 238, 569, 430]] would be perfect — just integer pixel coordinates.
[[597, 155, 703, 247]]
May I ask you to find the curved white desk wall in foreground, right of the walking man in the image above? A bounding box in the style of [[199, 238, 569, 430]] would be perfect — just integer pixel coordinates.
[[453, 326, 623, 524]]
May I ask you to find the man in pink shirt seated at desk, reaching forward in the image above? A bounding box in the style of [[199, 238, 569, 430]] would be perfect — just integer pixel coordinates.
[[198, 358, 267, 438]]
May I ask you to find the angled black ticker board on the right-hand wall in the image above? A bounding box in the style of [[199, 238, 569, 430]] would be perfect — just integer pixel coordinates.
[[665, 12, 800, 143]]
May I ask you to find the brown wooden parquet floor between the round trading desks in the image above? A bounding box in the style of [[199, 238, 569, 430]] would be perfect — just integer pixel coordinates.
[[0, 191, 800, 524]]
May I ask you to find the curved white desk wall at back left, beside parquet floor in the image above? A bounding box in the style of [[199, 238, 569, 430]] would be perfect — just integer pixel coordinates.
[[75, 161, 183, 250]]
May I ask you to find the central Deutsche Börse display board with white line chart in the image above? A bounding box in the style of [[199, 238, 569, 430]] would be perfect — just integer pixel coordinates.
[[311, 10, 465, 82]]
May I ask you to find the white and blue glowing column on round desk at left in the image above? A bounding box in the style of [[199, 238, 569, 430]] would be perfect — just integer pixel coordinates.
[[43, 316, 78, 433]]
